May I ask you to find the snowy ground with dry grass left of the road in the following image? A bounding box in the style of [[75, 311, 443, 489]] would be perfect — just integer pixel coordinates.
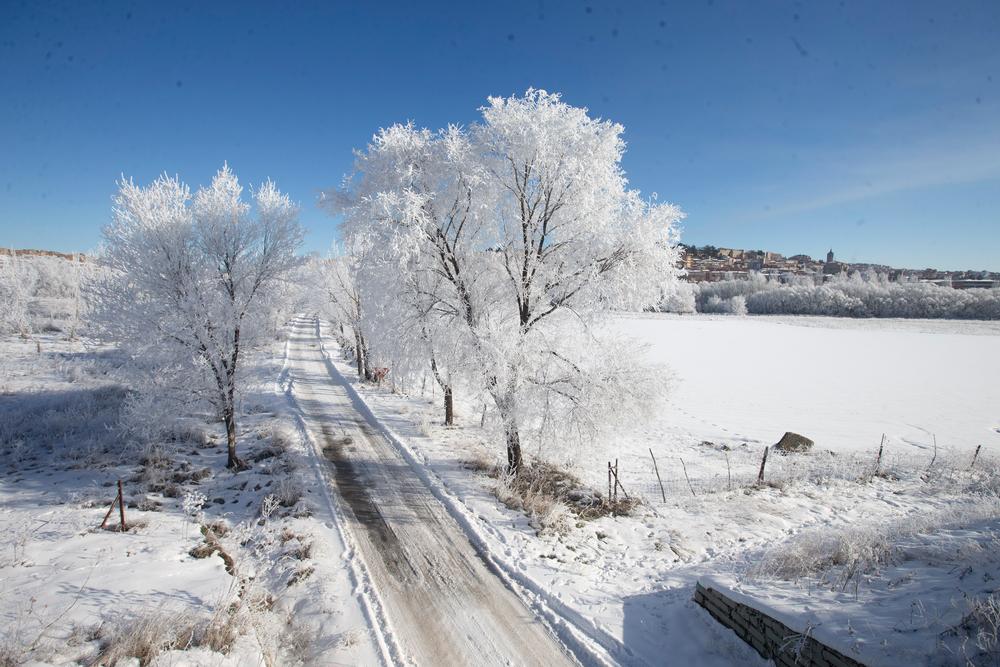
[[0, 335, 379, 665]]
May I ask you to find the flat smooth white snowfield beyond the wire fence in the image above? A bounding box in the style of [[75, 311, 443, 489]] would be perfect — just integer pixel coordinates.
[[616, 314, 1000, 454]]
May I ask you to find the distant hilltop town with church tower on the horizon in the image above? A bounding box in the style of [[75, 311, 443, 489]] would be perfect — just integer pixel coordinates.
[[680, 243, 1000, 289]]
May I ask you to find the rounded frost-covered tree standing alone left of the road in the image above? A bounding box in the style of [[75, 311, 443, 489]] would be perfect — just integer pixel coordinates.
[[95, 166, 303, 469]]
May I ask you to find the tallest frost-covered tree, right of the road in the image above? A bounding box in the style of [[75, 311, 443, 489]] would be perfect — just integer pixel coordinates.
[[472, 90, 681, 471]]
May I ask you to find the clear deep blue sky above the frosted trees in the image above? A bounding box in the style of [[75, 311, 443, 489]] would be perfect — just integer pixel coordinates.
[[0, 0, 1000, 270]]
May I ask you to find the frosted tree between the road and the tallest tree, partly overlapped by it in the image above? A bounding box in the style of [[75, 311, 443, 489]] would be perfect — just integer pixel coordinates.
[[325, 125, 482, 425]]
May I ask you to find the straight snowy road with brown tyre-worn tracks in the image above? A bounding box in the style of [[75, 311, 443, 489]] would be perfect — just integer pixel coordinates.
[[288, 319, 574, 665]]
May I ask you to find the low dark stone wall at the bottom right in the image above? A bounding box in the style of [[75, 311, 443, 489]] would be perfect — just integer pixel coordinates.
[[694, 583, 864, 667]]
